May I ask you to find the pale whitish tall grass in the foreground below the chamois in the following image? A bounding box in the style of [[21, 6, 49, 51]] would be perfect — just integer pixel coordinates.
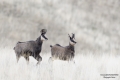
[[0, 48, 120, 80]]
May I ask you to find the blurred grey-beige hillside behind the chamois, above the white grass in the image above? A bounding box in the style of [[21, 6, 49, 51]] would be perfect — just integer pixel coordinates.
[[0, 0, 120, 54]]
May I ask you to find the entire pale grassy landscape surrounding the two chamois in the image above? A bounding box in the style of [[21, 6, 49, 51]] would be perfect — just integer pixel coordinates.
[[0, 0, 120, 80]]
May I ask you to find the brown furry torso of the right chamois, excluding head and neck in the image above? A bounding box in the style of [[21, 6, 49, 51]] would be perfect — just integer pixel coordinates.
[[51, 44, 75, 61]]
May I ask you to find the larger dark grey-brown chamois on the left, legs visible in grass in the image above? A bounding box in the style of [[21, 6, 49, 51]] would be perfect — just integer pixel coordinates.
[[14, 29, 48, 64]]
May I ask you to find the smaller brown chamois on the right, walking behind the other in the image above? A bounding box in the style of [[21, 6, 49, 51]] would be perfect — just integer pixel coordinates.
[[49, 34, 76, 61]]
